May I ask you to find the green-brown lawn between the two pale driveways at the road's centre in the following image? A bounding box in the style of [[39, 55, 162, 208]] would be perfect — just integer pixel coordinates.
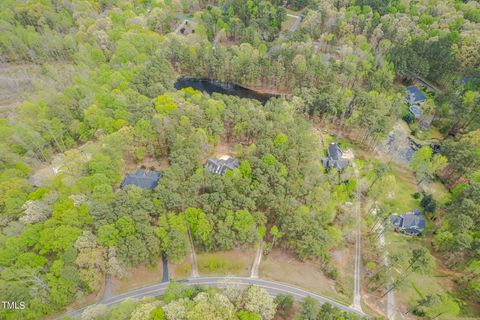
[[197, 246, 256, 276]]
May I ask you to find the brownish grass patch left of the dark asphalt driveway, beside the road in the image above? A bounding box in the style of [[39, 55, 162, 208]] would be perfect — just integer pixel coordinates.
[[112, 258, 163, 295]]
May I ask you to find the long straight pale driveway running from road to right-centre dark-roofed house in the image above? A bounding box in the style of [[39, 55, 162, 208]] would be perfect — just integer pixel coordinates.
[[352, 161, 362, 312]]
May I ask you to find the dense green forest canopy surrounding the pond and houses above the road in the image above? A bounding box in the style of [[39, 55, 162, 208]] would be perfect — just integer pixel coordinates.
[[0, 0, 480, 319]]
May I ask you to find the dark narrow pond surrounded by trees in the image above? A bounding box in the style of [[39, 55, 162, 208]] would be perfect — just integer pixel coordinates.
[[174, 77, 277, 104]]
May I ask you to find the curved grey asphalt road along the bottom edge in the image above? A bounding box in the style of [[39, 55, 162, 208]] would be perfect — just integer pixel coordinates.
[[62, 277, 365, 319]]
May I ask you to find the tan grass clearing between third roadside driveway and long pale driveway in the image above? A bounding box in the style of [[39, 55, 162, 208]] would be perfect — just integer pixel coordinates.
[[259, 249, 353, 304]]
